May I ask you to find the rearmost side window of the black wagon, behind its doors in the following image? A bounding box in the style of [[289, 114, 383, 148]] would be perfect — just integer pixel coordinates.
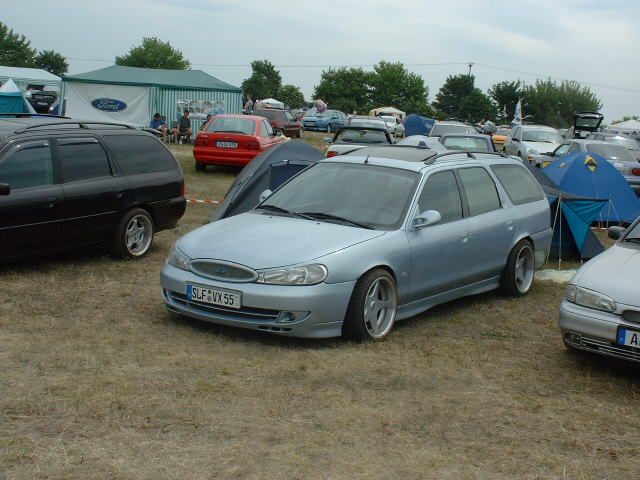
[[103, 135, 178, 175]]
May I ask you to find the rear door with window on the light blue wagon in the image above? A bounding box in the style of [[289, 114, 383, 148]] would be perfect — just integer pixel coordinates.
[[457, 166, 518, 283]]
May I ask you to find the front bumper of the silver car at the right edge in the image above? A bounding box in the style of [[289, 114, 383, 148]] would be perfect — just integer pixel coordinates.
[[559, 300, 640, 363]]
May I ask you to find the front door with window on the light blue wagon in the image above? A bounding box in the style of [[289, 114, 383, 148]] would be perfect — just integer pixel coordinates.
[[407, 170, 474, 302]]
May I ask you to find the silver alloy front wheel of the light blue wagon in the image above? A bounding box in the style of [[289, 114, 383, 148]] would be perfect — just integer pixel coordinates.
[[364, 277, 397, 338]]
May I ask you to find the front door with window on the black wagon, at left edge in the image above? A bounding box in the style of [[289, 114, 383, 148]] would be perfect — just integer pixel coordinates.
[[0, 139, 64, 258]]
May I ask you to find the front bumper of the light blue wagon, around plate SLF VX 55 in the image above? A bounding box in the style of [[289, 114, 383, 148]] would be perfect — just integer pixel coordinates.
[[160, 264, 355, 338]]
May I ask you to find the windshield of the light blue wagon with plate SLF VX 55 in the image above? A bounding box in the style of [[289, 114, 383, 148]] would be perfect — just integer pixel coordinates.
[[263, 162, 420, 230]]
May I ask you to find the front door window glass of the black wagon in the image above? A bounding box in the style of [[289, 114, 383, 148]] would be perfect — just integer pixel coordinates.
[[0, 142, 53, 190]]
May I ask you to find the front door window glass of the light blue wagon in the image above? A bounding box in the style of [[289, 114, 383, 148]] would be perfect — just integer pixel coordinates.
[[418, 171, 462, 223]]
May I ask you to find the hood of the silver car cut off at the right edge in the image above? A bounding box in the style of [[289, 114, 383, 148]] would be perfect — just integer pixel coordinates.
[[571, 243, 640, 306]]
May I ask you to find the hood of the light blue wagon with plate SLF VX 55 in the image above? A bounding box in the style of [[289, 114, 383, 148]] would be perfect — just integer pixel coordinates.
[[178, 212, 385, 270]]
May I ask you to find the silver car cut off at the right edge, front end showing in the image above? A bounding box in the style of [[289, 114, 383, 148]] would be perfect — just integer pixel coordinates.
[[560, 218, 640, 363]]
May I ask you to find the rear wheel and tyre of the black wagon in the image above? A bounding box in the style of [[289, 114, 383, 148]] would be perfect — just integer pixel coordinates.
[[111, 208, 153, 258]]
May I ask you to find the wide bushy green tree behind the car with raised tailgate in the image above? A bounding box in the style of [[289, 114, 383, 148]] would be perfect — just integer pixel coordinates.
[[523, 79, 602, 128]]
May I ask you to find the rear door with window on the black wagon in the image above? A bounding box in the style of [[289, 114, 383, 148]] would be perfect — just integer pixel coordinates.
[[56, 137, 129, 244]]
